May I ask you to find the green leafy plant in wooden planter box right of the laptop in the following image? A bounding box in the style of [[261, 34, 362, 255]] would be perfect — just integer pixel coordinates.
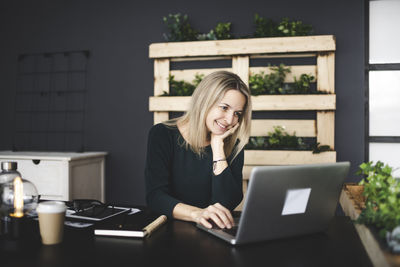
[[341, 161, 400, 258]]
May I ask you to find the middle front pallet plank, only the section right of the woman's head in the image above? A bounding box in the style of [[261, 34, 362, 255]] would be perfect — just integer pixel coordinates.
[[252, 95, 336, 111]]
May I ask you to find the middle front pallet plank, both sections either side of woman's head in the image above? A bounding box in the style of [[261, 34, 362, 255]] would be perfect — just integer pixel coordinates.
[[149, 95, 336, 111]]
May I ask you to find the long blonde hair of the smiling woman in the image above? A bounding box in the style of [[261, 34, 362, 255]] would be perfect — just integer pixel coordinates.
[[164, 71, 251, 161]]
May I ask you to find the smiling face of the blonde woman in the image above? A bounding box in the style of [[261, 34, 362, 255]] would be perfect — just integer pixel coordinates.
[[206, 89, 246, 135]]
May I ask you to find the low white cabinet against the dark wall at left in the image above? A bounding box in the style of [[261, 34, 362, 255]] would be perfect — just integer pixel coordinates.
[[0, 151, 107, 202]]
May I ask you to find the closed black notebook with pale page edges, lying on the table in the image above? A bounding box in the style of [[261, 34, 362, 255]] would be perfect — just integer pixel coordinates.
[[94, 211, 167, 237]]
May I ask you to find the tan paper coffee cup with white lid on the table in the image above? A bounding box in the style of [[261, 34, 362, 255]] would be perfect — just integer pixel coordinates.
[[36, 201, 67, 245]]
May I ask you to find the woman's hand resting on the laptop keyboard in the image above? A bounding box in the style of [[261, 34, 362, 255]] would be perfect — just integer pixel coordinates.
[[192, 203, 234, 229]]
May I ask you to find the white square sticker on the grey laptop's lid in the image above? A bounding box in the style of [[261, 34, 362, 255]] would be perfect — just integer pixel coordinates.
[[282, 188, 311, 215]]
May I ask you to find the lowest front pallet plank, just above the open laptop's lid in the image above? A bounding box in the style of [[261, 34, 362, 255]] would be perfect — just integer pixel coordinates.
[[244, 150, 336, 165]]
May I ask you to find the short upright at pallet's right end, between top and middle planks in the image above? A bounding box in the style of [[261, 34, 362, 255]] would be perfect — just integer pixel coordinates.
[[317, 52, 335, 94]]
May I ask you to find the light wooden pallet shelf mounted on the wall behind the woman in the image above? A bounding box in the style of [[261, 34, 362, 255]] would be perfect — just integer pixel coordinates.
[[149, 35, 336, 209]]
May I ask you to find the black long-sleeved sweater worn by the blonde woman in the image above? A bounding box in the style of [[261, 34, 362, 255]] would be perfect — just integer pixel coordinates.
[[145, 124, 244, 218]]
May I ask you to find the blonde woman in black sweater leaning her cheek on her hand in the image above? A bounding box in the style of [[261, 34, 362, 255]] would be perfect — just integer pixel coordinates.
[[145, 71, 251, 228]]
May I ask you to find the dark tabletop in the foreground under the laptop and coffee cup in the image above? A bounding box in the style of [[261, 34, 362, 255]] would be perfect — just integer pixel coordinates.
[[0, 217, 371, 267]]
